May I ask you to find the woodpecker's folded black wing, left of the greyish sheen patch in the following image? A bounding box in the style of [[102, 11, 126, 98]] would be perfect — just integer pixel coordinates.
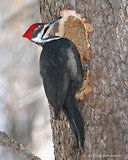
[[40, 40, 70, 119]]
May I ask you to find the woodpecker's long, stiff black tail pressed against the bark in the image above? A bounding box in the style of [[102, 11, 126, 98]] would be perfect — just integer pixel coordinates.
[[62, 97, 85, 150]]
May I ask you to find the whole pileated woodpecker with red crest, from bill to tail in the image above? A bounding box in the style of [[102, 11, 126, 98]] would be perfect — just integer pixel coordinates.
[[23, 17, 85, 150]]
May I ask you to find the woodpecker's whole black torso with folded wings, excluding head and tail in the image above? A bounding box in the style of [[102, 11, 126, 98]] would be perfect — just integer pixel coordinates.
[[40, 38, 82, 119]]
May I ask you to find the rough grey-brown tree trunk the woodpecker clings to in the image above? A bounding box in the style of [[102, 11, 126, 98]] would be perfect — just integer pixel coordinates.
[[40, 0, 128, 160]]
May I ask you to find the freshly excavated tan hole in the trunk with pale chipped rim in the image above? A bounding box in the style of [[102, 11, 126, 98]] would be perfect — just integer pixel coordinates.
[[56, 9, 93, 100]]
